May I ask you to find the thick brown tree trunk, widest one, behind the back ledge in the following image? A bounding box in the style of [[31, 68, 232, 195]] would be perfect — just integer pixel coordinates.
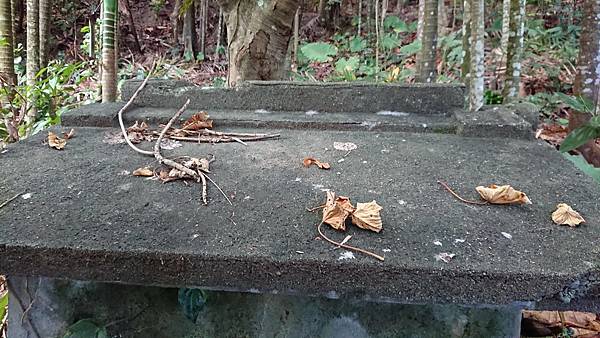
[[220, 0, 300, 86]]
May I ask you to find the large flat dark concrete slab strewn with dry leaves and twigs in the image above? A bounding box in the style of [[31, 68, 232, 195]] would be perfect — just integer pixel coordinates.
[[0, 128, 600, 311]]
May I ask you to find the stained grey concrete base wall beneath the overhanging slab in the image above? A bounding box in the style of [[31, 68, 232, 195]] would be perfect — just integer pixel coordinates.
[[9, 278, 521, 338]]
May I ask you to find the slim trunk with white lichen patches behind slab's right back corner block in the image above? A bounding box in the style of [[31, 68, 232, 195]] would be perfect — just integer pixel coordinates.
[[502, 0, 526, 102]]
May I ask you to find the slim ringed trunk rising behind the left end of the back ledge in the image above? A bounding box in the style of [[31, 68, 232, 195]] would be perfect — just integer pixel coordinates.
[[102, 0, 118, 102]]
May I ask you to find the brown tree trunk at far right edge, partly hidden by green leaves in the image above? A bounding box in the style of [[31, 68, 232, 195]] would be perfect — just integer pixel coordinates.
[[569, 1, 600, 167]]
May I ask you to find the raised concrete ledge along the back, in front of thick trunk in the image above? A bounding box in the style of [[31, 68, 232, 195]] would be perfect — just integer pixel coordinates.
[[122, 80, 465, 114]]
